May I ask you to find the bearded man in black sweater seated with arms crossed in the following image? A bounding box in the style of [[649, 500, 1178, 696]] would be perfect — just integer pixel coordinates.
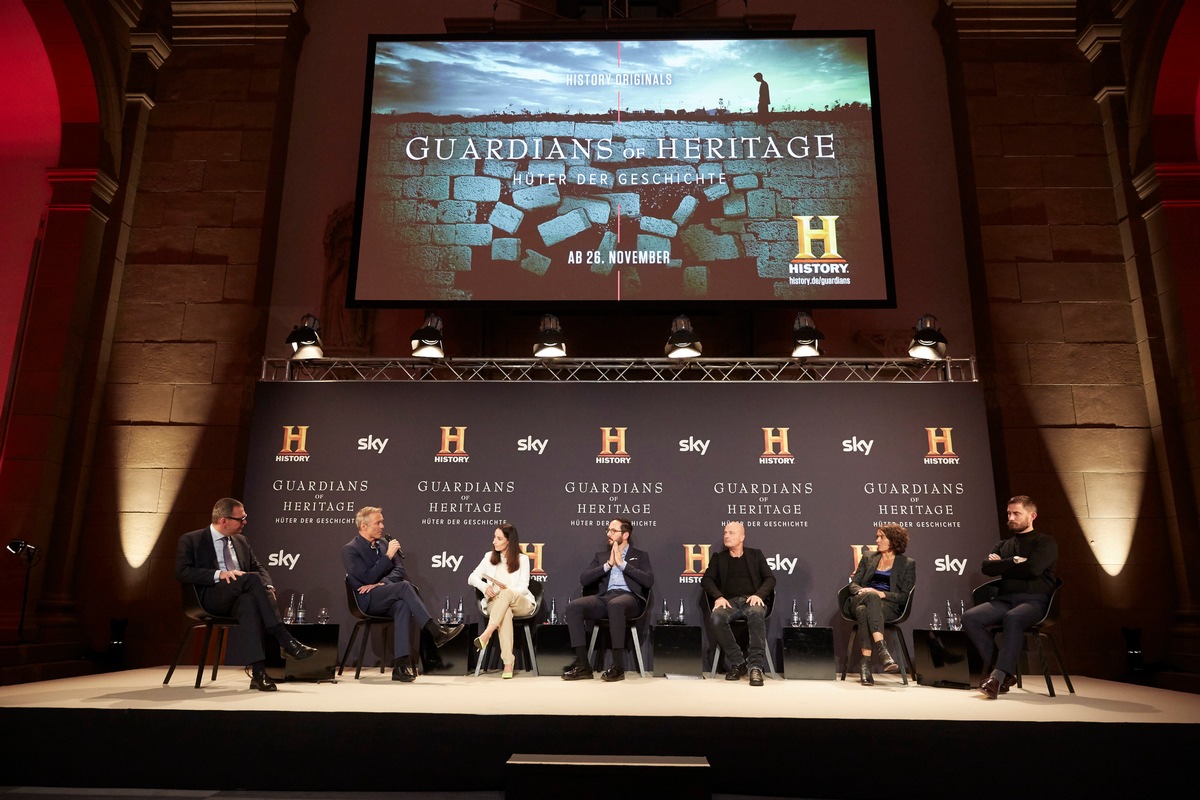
[[962, 494, 1058, 700]]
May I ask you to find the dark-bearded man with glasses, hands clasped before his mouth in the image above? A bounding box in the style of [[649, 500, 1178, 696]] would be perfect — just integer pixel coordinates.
[[563, 518, 654, 681]]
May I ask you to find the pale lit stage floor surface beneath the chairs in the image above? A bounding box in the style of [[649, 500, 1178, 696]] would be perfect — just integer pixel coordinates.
[[0, 666, 1200, 724]]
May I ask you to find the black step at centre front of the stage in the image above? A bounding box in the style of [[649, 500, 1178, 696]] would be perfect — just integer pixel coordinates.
[[504, 753, 713, 800]]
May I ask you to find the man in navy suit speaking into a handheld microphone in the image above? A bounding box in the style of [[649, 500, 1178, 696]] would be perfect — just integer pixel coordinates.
[[342, 506, 462, 684]]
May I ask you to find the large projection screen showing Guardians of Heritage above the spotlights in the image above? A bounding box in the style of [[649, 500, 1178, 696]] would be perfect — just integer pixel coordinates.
[[348, 32, 895, 307]]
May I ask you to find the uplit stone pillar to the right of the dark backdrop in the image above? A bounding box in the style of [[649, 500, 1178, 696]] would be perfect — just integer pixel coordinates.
[[937, 0, 1171, 676]]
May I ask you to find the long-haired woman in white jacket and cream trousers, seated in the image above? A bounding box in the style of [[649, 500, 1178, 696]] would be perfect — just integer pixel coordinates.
[[467, 523, 534, 678]]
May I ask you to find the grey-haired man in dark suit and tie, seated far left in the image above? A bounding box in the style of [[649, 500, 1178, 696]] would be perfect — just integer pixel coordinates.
[[175, 498, 317, 692]]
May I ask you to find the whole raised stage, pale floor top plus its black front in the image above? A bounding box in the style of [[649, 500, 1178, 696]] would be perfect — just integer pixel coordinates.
[[0, 667, 1200, 800]]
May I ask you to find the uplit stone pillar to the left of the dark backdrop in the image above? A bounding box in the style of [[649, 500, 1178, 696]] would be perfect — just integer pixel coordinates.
[[79, 0, 307, 663]]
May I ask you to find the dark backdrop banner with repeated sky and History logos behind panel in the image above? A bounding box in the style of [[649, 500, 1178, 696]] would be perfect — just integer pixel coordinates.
[[244, 381, 1003, 666]]
